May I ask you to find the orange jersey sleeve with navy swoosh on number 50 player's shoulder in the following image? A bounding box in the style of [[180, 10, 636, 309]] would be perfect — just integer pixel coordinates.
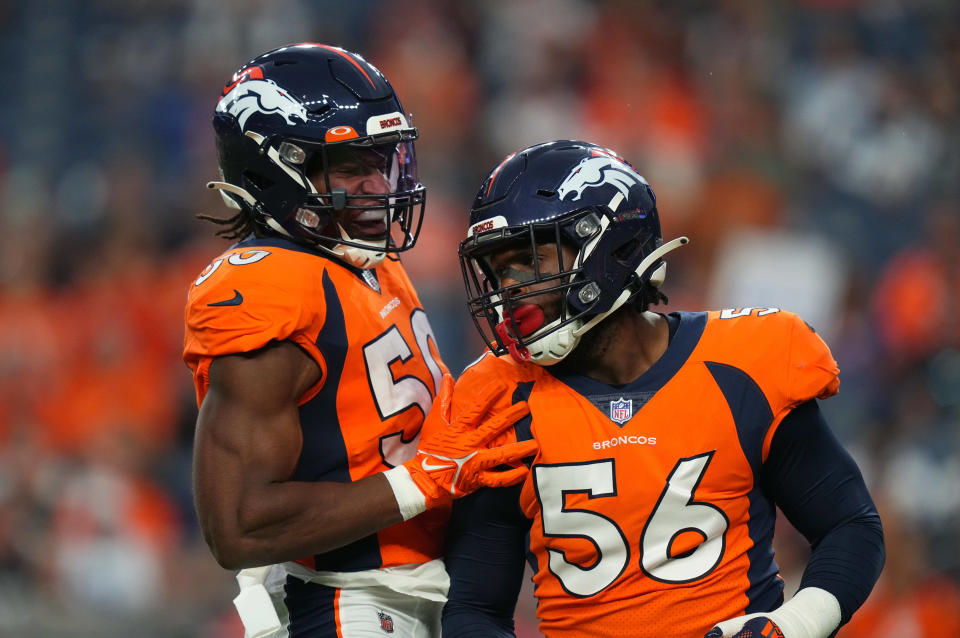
[[183, 250, 337, 403]]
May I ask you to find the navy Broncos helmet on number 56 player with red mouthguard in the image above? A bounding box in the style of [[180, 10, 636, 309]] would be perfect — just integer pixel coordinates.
[[459, 140, 688, 366]]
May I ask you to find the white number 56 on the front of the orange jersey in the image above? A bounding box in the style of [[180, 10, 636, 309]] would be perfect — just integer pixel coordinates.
[[533, 452, 730, 598]]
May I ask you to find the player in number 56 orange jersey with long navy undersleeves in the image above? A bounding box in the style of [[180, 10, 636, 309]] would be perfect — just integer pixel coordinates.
[[443, 140, 884, 638]]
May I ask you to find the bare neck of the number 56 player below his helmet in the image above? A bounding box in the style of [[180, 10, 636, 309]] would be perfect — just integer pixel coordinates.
[[557, 311, 670, 385]]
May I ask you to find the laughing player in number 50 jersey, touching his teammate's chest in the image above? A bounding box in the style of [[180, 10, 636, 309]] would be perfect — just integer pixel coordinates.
[[184, 44, 535, 638]]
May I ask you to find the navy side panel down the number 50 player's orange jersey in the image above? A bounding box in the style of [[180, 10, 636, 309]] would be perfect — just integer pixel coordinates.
[[293, 272, 381, 571]]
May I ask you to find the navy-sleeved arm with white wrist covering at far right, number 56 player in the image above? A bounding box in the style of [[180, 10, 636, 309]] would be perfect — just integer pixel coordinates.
[[708, 401, 885, 638]]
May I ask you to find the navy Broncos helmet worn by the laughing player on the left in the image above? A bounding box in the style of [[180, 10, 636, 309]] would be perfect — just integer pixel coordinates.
[[207, 43, 426, 268]]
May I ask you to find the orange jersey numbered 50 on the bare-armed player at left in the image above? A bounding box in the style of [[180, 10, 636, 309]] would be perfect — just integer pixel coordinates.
[[183, 238, 447, 571]]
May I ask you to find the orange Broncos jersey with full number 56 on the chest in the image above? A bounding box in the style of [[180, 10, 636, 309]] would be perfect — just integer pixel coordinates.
[[455, 308, 839, 638]]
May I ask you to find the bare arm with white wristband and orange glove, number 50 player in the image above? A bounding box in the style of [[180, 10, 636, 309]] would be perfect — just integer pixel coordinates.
[[194, 341, 536, 569]]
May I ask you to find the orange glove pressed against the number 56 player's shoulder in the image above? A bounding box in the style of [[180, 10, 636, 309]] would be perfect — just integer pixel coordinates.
[[404, 374, 538, 509]]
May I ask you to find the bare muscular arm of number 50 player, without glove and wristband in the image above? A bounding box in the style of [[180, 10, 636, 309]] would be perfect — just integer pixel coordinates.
[[193, 341, 402, 569]]
